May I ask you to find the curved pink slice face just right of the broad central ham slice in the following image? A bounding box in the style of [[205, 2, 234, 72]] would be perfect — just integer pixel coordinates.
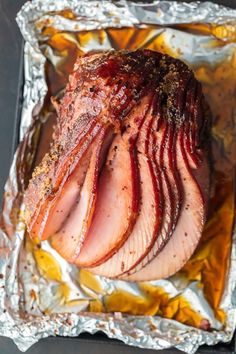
[[86, 99, 161, 277]]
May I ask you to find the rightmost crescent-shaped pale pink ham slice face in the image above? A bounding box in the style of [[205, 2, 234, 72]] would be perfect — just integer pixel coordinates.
[[122, 131, 207, 281]]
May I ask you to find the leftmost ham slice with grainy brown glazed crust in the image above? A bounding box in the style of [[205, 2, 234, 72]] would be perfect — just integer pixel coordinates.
[[25, 120, 100, 240]]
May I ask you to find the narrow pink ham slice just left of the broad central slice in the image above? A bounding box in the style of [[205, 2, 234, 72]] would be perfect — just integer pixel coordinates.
[[51, 127, 113, 262]]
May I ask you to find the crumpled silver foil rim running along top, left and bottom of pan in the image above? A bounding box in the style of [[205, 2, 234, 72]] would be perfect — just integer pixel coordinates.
[[0, 0, 236, 354]]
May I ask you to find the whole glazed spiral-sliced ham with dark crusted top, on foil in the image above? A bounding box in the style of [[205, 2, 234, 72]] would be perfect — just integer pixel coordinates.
[[24, 50, 210, 281]]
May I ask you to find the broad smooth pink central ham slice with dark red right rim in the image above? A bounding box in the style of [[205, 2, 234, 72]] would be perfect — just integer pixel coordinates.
[[75, 96, 150, 267]]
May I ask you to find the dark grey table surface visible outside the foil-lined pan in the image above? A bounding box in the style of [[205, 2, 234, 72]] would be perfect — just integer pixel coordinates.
[[0, 0, 236, 354]]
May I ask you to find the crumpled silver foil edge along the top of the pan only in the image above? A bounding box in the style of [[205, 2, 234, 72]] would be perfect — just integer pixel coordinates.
[[17, 0, 236, 49]]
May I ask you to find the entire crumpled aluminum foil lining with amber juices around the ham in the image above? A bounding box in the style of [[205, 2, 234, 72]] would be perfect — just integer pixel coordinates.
[[0, 0, 236, 353]]
